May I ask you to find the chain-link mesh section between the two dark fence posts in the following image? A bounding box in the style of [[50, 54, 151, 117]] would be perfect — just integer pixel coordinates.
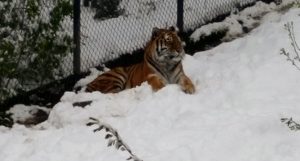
[[81, 0, 176, 71]]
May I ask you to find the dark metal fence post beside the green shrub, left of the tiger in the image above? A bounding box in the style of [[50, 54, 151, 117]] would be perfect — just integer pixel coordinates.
[[73, 0, 80, 75]]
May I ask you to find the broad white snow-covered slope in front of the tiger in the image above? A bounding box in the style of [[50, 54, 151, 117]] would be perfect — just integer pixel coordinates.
[[0, 4, 300, 161]]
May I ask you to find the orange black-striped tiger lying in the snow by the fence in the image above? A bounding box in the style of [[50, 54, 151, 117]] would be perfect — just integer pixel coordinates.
[[86, 26, 195, 94]]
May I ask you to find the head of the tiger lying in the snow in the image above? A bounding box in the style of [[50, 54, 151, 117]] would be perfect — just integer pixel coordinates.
[[150, 26, 185, 64]]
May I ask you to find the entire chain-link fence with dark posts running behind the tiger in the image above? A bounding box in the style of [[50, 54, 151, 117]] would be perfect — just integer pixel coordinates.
[[0, 0, 278, 105]]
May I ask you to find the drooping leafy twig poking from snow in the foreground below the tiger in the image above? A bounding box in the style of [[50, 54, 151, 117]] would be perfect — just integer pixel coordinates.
[[86, 117, 142, 161]]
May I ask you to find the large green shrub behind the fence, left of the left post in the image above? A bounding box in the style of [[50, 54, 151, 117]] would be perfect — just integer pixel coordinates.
[[0, 0, 72, 103]]
